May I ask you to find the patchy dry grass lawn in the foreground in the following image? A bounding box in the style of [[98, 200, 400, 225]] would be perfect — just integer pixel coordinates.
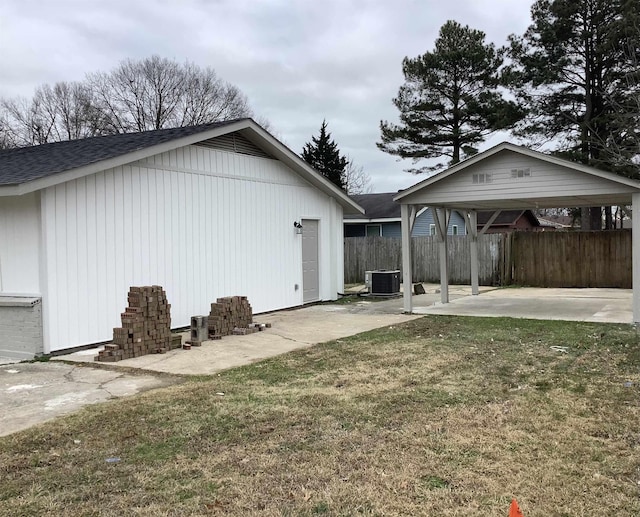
[[0, 316, 640, 517]]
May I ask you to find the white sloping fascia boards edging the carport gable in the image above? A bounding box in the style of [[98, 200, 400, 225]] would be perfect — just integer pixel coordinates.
[[393, 142, 640, 203]]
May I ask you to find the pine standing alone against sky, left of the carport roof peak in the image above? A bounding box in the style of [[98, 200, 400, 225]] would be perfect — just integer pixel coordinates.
[[378, 21, 522, 173]]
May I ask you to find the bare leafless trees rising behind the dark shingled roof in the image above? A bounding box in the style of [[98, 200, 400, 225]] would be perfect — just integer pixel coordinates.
[[0, 56, 260, 147]]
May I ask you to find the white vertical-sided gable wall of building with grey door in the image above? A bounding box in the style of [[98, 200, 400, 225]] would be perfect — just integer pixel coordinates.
[[43, 146, 342, 350]]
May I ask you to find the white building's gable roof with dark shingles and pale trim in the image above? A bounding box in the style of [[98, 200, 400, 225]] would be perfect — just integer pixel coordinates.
[[0, 118, 363, 214]]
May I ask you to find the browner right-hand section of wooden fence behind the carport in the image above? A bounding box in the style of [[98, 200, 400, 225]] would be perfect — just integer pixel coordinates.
[[502, 230, 631, 289]]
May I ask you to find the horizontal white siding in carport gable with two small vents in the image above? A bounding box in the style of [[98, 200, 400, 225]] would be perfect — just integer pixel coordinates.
[[408, 151, 636, 204]]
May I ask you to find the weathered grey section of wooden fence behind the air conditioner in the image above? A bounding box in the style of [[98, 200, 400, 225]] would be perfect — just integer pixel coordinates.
[[344, 234, 505, 285]]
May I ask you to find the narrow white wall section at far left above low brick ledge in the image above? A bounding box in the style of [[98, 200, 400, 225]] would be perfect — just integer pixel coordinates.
[[0, 194, 40, 295]]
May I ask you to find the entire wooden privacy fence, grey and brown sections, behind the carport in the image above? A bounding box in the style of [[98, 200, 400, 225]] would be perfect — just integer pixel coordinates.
[[344, 230, 631, 289]]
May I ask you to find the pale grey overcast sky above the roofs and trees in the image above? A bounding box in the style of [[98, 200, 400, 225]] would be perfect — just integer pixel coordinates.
[[0, 0, 533, 192]]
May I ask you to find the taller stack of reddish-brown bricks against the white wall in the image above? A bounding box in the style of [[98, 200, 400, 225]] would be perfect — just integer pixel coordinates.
[[95, 285, 172, 362]]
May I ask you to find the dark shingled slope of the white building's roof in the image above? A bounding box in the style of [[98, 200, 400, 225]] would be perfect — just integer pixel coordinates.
[[0, 119, 241, 186]]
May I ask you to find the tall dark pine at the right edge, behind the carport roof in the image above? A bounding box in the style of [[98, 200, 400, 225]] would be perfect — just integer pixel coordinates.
[[506, 0, 640, 229]]
